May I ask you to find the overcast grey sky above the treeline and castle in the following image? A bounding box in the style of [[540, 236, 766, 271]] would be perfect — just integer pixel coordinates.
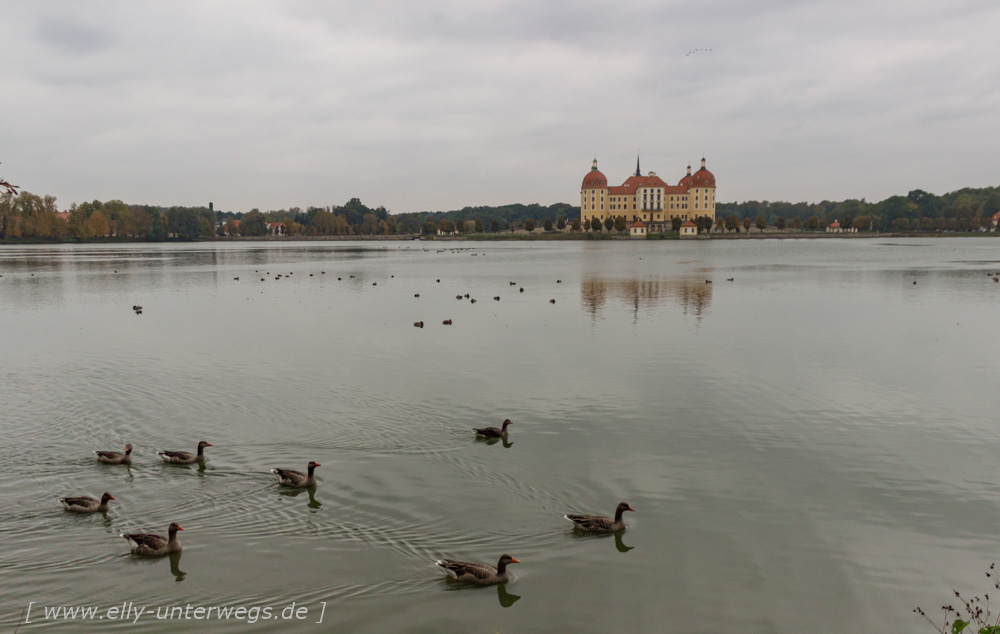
[[0, 0, 1000, 213]]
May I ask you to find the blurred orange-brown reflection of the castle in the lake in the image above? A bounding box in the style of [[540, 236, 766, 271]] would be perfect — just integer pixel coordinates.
[[580, 275, 712, 321]]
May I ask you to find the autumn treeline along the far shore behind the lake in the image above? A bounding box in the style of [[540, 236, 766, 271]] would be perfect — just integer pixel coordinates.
[[0, 187, 1000, 243]]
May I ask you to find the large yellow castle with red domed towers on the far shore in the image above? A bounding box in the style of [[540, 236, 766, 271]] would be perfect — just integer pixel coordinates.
[[580, 159, 715, 233]]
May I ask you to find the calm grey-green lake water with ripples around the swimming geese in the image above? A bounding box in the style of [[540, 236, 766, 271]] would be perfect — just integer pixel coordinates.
[[0, 238, 1000, 633]]
